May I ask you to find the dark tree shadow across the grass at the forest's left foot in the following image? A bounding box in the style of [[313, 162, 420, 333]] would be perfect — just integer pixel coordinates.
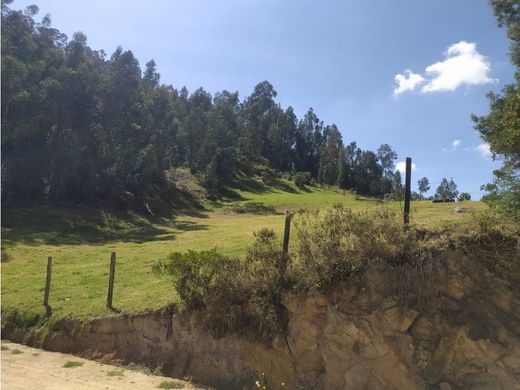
[[2, 206, 208, 245]]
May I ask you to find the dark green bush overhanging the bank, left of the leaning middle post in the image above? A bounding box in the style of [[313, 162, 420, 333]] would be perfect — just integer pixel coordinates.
[[160, 236, 288, 339]]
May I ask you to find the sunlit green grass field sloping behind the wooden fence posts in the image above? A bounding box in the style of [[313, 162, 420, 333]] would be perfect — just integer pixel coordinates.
[[1, 181, 485, 319]]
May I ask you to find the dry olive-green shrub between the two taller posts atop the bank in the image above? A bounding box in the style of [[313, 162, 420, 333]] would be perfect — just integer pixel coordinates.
[[295, 204, 410, 290]]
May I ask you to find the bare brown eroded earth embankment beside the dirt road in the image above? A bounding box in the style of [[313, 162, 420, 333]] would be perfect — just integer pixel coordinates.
[[4, 251, 520, 389]]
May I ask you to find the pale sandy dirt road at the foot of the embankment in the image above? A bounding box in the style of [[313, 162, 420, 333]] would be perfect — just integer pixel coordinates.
[[1, 341, 209, 390]]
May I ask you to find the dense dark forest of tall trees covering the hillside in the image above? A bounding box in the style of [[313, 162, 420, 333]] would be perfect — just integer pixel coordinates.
[[2, 1, 401, 207]]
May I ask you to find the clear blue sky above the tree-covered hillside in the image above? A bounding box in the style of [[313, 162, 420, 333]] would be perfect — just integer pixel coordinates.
[[11, 0, 514, 198]]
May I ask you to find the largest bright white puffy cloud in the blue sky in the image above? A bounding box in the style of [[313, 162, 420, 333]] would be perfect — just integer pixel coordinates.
[[394, 41, 497, 96]]
